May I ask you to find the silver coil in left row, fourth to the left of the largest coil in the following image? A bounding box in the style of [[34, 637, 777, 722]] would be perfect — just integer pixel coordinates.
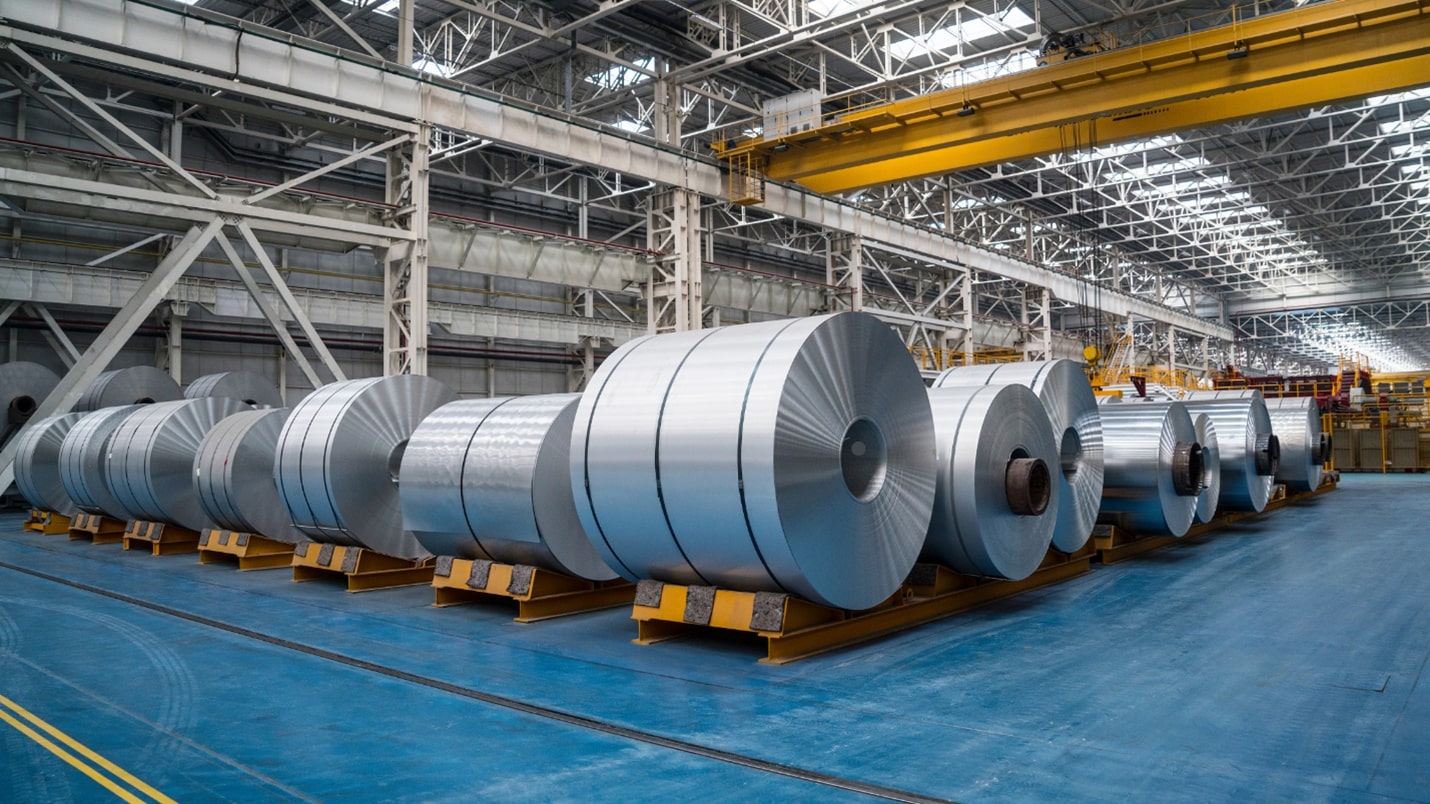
[[106, 399, 247, 531]]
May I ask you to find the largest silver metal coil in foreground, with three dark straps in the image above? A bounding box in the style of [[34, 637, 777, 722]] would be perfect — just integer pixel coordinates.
[[571, 313, 937, 609]]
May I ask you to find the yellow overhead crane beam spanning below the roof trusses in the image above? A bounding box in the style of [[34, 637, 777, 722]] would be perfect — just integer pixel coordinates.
[[715, 0, 1430, 203]]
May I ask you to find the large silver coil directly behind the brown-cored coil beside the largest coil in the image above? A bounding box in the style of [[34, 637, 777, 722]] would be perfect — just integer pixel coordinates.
[[934, 361, 1103, 552]]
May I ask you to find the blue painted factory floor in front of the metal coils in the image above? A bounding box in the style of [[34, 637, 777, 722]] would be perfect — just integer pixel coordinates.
[[0, 475, 1430, 801]]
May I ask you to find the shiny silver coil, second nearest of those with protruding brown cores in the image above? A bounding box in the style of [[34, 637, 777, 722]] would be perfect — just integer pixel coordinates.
[[1098, 402, 1206, 536]]
